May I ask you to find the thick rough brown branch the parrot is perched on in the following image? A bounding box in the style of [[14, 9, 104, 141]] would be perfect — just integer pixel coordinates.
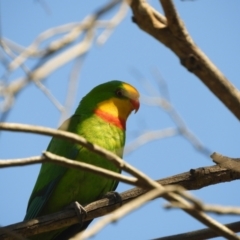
[[0, 165, 240, 240]]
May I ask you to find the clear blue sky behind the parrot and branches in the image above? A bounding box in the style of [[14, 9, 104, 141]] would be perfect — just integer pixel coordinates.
[[0, 0, 240, 239]]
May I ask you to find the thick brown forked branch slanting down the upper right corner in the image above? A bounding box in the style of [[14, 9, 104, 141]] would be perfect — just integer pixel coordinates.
[[130, 0, 240, 120]]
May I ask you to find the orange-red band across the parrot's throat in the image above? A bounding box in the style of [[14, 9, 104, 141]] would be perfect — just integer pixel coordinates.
[[94, 108, 126, 130]]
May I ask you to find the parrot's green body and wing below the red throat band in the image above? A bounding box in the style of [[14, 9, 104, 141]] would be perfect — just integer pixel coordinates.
[[25, 115, 125, 220]]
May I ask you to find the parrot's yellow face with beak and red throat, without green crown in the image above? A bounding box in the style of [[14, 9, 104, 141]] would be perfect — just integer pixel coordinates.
[[95, 83, 140, 128]]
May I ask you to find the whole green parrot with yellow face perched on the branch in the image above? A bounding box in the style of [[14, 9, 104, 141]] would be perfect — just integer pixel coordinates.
[[24, 80, 140, 240]]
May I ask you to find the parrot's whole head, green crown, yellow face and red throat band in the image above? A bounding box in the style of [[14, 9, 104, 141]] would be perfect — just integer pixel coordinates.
[[79, 80, 140, 128]]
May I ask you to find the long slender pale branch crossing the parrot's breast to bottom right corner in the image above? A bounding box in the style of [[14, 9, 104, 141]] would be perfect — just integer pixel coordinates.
[[0, 123, 239, 239]]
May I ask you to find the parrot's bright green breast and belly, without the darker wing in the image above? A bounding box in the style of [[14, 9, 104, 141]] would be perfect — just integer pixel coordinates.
[[41, 115, 125, 213]]
